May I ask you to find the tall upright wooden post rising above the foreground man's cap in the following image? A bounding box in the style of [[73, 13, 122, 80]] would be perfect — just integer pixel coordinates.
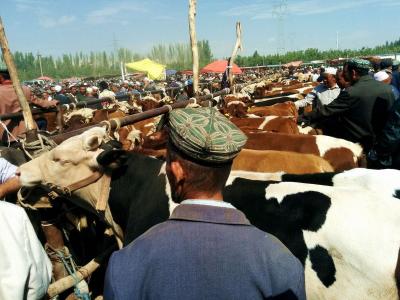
[[189, 0, 199, 96]]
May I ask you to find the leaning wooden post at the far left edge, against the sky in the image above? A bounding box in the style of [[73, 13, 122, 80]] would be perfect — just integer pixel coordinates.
[[0, 17, 37, 141]]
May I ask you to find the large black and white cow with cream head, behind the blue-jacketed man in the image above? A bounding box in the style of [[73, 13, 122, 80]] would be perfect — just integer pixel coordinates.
[[20, 128, 400, 299]]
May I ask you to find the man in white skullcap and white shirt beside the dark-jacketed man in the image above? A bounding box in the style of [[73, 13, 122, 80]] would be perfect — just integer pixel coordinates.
[[294, 67, 340, 109]]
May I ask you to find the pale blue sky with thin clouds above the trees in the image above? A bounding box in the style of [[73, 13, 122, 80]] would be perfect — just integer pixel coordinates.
[[0, 0, 400, 58]]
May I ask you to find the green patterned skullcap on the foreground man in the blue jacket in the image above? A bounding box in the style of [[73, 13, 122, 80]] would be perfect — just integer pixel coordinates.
[[168, 107, 247, 163]]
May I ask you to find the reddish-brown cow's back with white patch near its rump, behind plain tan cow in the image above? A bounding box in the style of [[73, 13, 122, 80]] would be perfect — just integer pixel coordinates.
[[245, 132, 362, 172]]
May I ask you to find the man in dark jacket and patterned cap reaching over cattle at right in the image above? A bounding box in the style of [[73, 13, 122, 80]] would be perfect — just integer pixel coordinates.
[[299, 59, 394, 150]]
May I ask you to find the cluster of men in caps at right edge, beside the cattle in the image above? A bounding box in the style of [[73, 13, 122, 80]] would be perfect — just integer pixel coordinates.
[[295, 59, 400, 168]]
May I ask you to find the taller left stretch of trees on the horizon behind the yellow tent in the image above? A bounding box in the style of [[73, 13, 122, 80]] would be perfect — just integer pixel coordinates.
[[0, 41, 213, 80]]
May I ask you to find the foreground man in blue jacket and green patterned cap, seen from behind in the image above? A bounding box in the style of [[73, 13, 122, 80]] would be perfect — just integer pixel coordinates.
[[104, 107, 305, 299]]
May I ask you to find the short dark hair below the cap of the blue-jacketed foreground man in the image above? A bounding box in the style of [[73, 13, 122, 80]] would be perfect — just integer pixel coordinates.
[[167, 140, 232, 194]]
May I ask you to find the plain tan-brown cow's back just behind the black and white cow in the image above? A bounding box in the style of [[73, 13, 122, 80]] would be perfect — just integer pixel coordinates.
[[232, 149, 334, 174]]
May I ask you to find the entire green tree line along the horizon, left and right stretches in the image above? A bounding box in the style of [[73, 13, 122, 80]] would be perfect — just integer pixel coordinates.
[[0, 39, 400, 80]]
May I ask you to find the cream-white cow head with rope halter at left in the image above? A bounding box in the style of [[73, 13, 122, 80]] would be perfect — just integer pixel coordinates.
[[19, 127, 107, 186]]
